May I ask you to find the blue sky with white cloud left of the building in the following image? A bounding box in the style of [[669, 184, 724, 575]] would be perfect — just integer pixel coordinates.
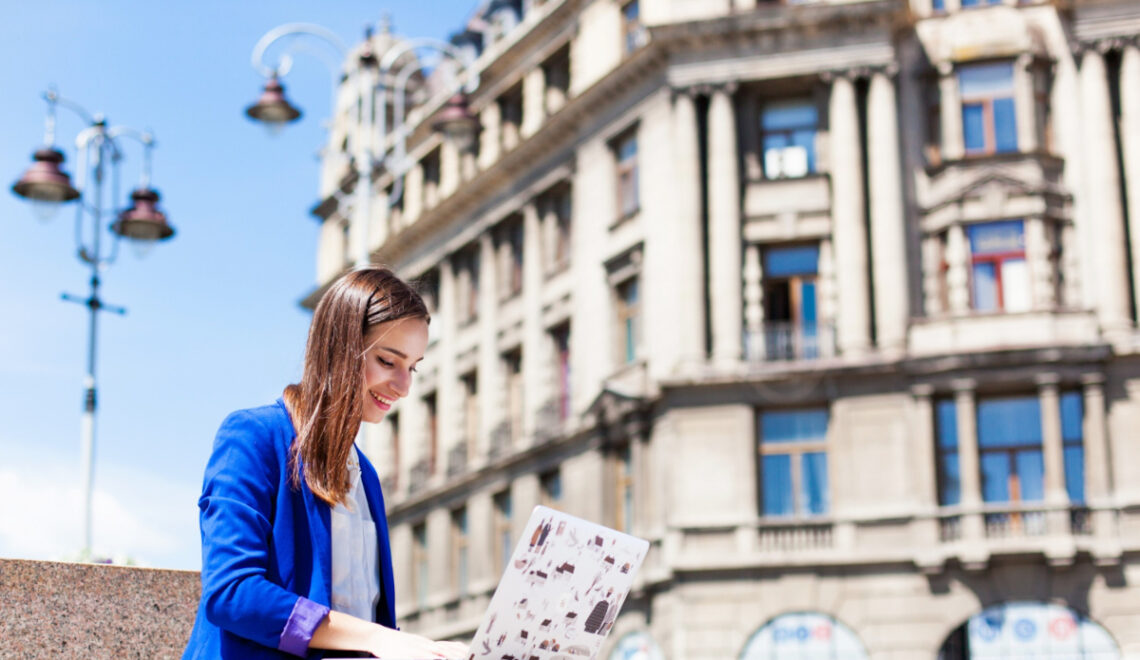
[[0, 0, 478, 569]]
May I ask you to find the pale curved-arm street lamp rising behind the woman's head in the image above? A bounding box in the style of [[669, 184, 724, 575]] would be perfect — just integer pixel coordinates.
[[245, 19, 479, 267]]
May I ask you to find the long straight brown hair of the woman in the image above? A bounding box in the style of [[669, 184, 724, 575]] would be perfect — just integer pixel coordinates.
[[284, 267, 430, 506]]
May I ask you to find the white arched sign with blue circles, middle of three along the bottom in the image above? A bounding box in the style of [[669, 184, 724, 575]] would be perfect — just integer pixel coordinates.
[[740, 612, 866, 660]]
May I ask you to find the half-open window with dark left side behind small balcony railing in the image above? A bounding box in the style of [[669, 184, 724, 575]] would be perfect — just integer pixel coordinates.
[[763, 245, 820, 360]]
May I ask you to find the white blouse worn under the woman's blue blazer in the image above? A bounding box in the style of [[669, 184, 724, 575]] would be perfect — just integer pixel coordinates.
[[332, 446, 380, 621]]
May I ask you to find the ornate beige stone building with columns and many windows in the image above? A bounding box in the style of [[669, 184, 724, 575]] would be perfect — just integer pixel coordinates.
[[306, 0, 1140, 660]]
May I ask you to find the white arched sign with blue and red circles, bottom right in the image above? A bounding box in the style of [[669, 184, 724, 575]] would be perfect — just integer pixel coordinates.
[[967, 603, 1121, 660]]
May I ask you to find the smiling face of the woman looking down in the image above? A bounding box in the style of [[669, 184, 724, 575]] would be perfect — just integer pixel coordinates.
[[363, 318, 428, 424]]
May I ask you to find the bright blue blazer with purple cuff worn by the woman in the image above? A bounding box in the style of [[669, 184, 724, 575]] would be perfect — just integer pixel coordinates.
[[182, 399, 396, 660]]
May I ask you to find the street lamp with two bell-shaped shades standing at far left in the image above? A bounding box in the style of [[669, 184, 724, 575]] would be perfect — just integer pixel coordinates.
[[11, 90, 174, 559]]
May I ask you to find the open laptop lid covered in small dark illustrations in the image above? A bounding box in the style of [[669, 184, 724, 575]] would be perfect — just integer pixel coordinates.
[[469, 506, 649, 660]]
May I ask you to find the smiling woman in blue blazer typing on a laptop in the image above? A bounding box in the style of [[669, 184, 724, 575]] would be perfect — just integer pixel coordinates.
[[184, 268, 466, 660]]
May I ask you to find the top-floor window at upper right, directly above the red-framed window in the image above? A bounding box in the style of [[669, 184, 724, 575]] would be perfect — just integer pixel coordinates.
[[958, 62, 1017, 155]]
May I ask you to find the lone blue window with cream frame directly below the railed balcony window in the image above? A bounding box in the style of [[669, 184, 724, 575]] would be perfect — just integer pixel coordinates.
[[759, 408, 830, 516]]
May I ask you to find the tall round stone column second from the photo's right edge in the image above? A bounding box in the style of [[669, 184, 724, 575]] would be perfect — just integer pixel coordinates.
[[1080, 48, 1131, 337]]
